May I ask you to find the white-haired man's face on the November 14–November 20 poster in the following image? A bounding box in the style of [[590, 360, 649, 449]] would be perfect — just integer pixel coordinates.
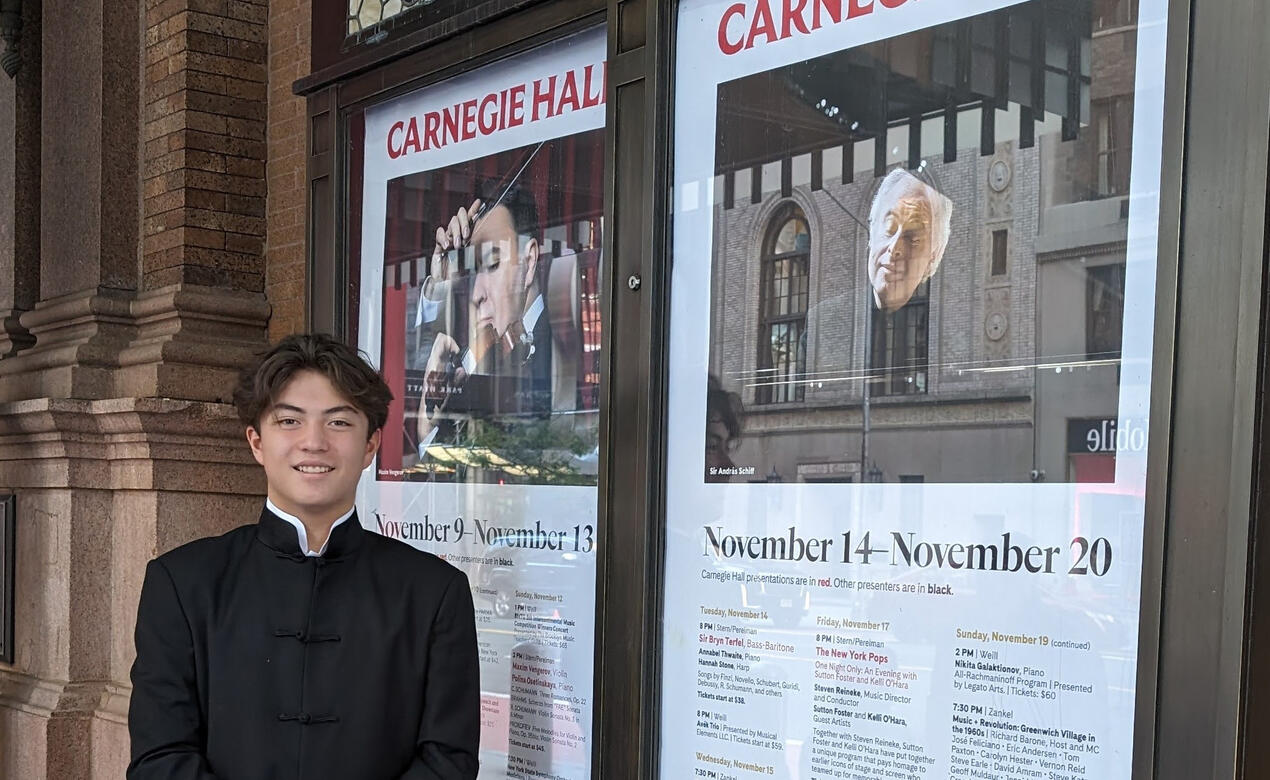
[[869, 175, 935, 311]]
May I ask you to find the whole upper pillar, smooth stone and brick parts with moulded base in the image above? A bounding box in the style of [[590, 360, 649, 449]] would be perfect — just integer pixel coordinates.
[[0, 0, 268, 401]]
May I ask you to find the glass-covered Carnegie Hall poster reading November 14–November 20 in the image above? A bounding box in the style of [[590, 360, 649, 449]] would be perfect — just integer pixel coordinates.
[[658, 0, 1166, 780]]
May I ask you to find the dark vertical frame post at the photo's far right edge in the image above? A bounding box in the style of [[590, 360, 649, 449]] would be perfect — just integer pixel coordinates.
[[1153, 0, 1270, 780]]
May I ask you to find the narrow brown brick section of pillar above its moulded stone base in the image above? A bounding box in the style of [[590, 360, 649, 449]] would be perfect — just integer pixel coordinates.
[[142, 0, 268, 292]]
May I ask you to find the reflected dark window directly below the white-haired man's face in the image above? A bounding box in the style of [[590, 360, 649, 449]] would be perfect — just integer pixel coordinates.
[[869, 281, 931, 395]]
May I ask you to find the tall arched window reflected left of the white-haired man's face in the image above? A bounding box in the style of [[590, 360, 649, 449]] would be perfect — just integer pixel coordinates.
[[756, 203, 812, 404]]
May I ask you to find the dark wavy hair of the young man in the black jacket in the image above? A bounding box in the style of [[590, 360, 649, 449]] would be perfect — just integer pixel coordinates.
[[234, 333, 392, 433]]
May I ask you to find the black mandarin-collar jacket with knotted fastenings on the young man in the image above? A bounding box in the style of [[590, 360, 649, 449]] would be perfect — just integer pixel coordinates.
[[128, 509, 480, 780]]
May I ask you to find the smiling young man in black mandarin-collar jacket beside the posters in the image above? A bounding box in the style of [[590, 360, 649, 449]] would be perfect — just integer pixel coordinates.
[[128, 335, 480, 780]]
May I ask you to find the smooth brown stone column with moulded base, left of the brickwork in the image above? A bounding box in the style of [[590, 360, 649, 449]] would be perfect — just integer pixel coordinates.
[[0, 0, 147, 400]]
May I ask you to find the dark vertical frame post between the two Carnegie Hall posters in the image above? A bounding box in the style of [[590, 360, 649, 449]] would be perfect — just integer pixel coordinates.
[[592, 0, 674, 777]]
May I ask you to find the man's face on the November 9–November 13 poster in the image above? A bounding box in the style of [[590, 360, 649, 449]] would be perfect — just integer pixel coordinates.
[[471, 206, 538, 335]]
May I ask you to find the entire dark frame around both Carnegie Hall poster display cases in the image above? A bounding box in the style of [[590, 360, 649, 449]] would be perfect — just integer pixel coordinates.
[[297, 0, 1270, 780]]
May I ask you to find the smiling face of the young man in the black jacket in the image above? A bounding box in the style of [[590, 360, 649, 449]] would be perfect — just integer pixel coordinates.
[[246, 371, 380, 521]]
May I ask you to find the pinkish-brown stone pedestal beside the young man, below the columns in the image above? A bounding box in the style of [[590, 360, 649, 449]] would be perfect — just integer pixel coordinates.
[[0, 398, 264, 779]]
